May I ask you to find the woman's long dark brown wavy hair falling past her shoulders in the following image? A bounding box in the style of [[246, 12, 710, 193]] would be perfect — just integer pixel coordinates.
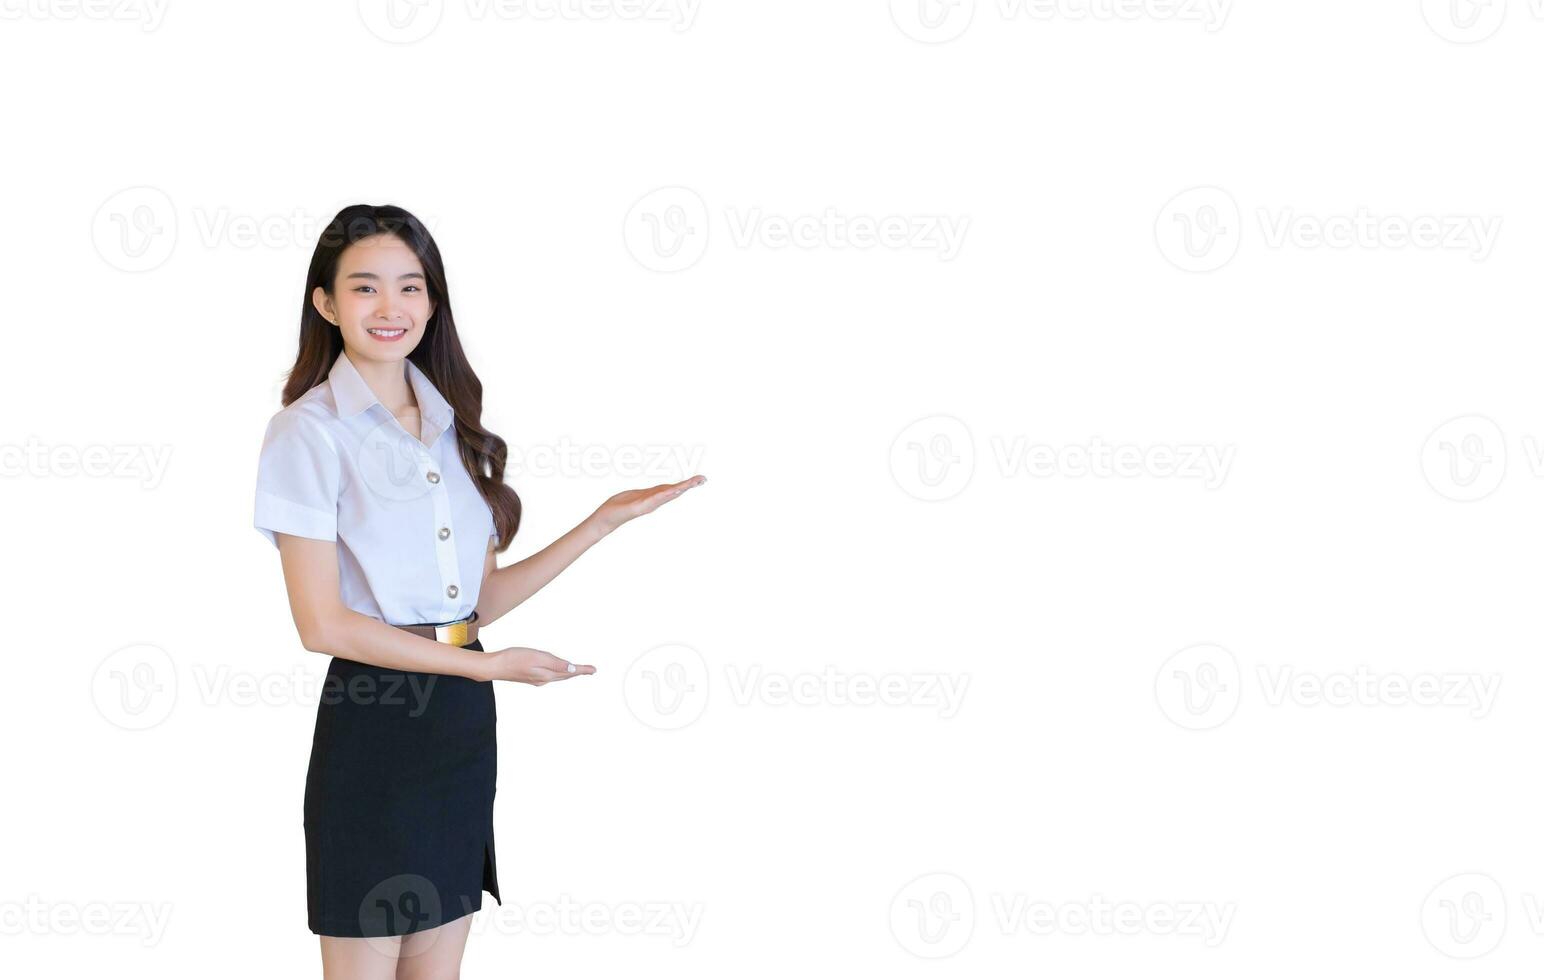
[[284, 204, 520, 551]]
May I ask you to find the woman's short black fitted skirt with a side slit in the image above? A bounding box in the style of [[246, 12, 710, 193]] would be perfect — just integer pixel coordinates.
[[297, 640, 503, 937]]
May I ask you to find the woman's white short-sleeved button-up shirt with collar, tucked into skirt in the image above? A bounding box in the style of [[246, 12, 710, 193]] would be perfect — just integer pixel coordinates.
[[253, 353, 496, 625]]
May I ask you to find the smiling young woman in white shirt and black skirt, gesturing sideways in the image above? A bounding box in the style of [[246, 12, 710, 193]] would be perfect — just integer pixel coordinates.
[[255, 205, 706, 978]]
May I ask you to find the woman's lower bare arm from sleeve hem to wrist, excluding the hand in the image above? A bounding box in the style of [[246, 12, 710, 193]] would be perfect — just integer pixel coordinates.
[[275, 534, 494, 681]]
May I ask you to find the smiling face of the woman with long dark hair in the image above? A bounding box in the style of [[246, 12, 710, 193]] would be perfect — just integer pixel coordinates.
[[310, 235, 434, 361]]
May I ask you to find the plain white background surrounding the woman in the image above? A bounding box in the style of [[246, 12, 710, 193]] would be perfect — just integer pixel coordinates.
[[0, 0, 1544, 978]]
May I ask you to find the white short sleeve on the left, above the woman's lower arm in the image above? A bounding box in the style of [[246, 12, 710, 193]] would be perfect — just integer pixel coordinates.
[[253, 412, 340, 548]]
